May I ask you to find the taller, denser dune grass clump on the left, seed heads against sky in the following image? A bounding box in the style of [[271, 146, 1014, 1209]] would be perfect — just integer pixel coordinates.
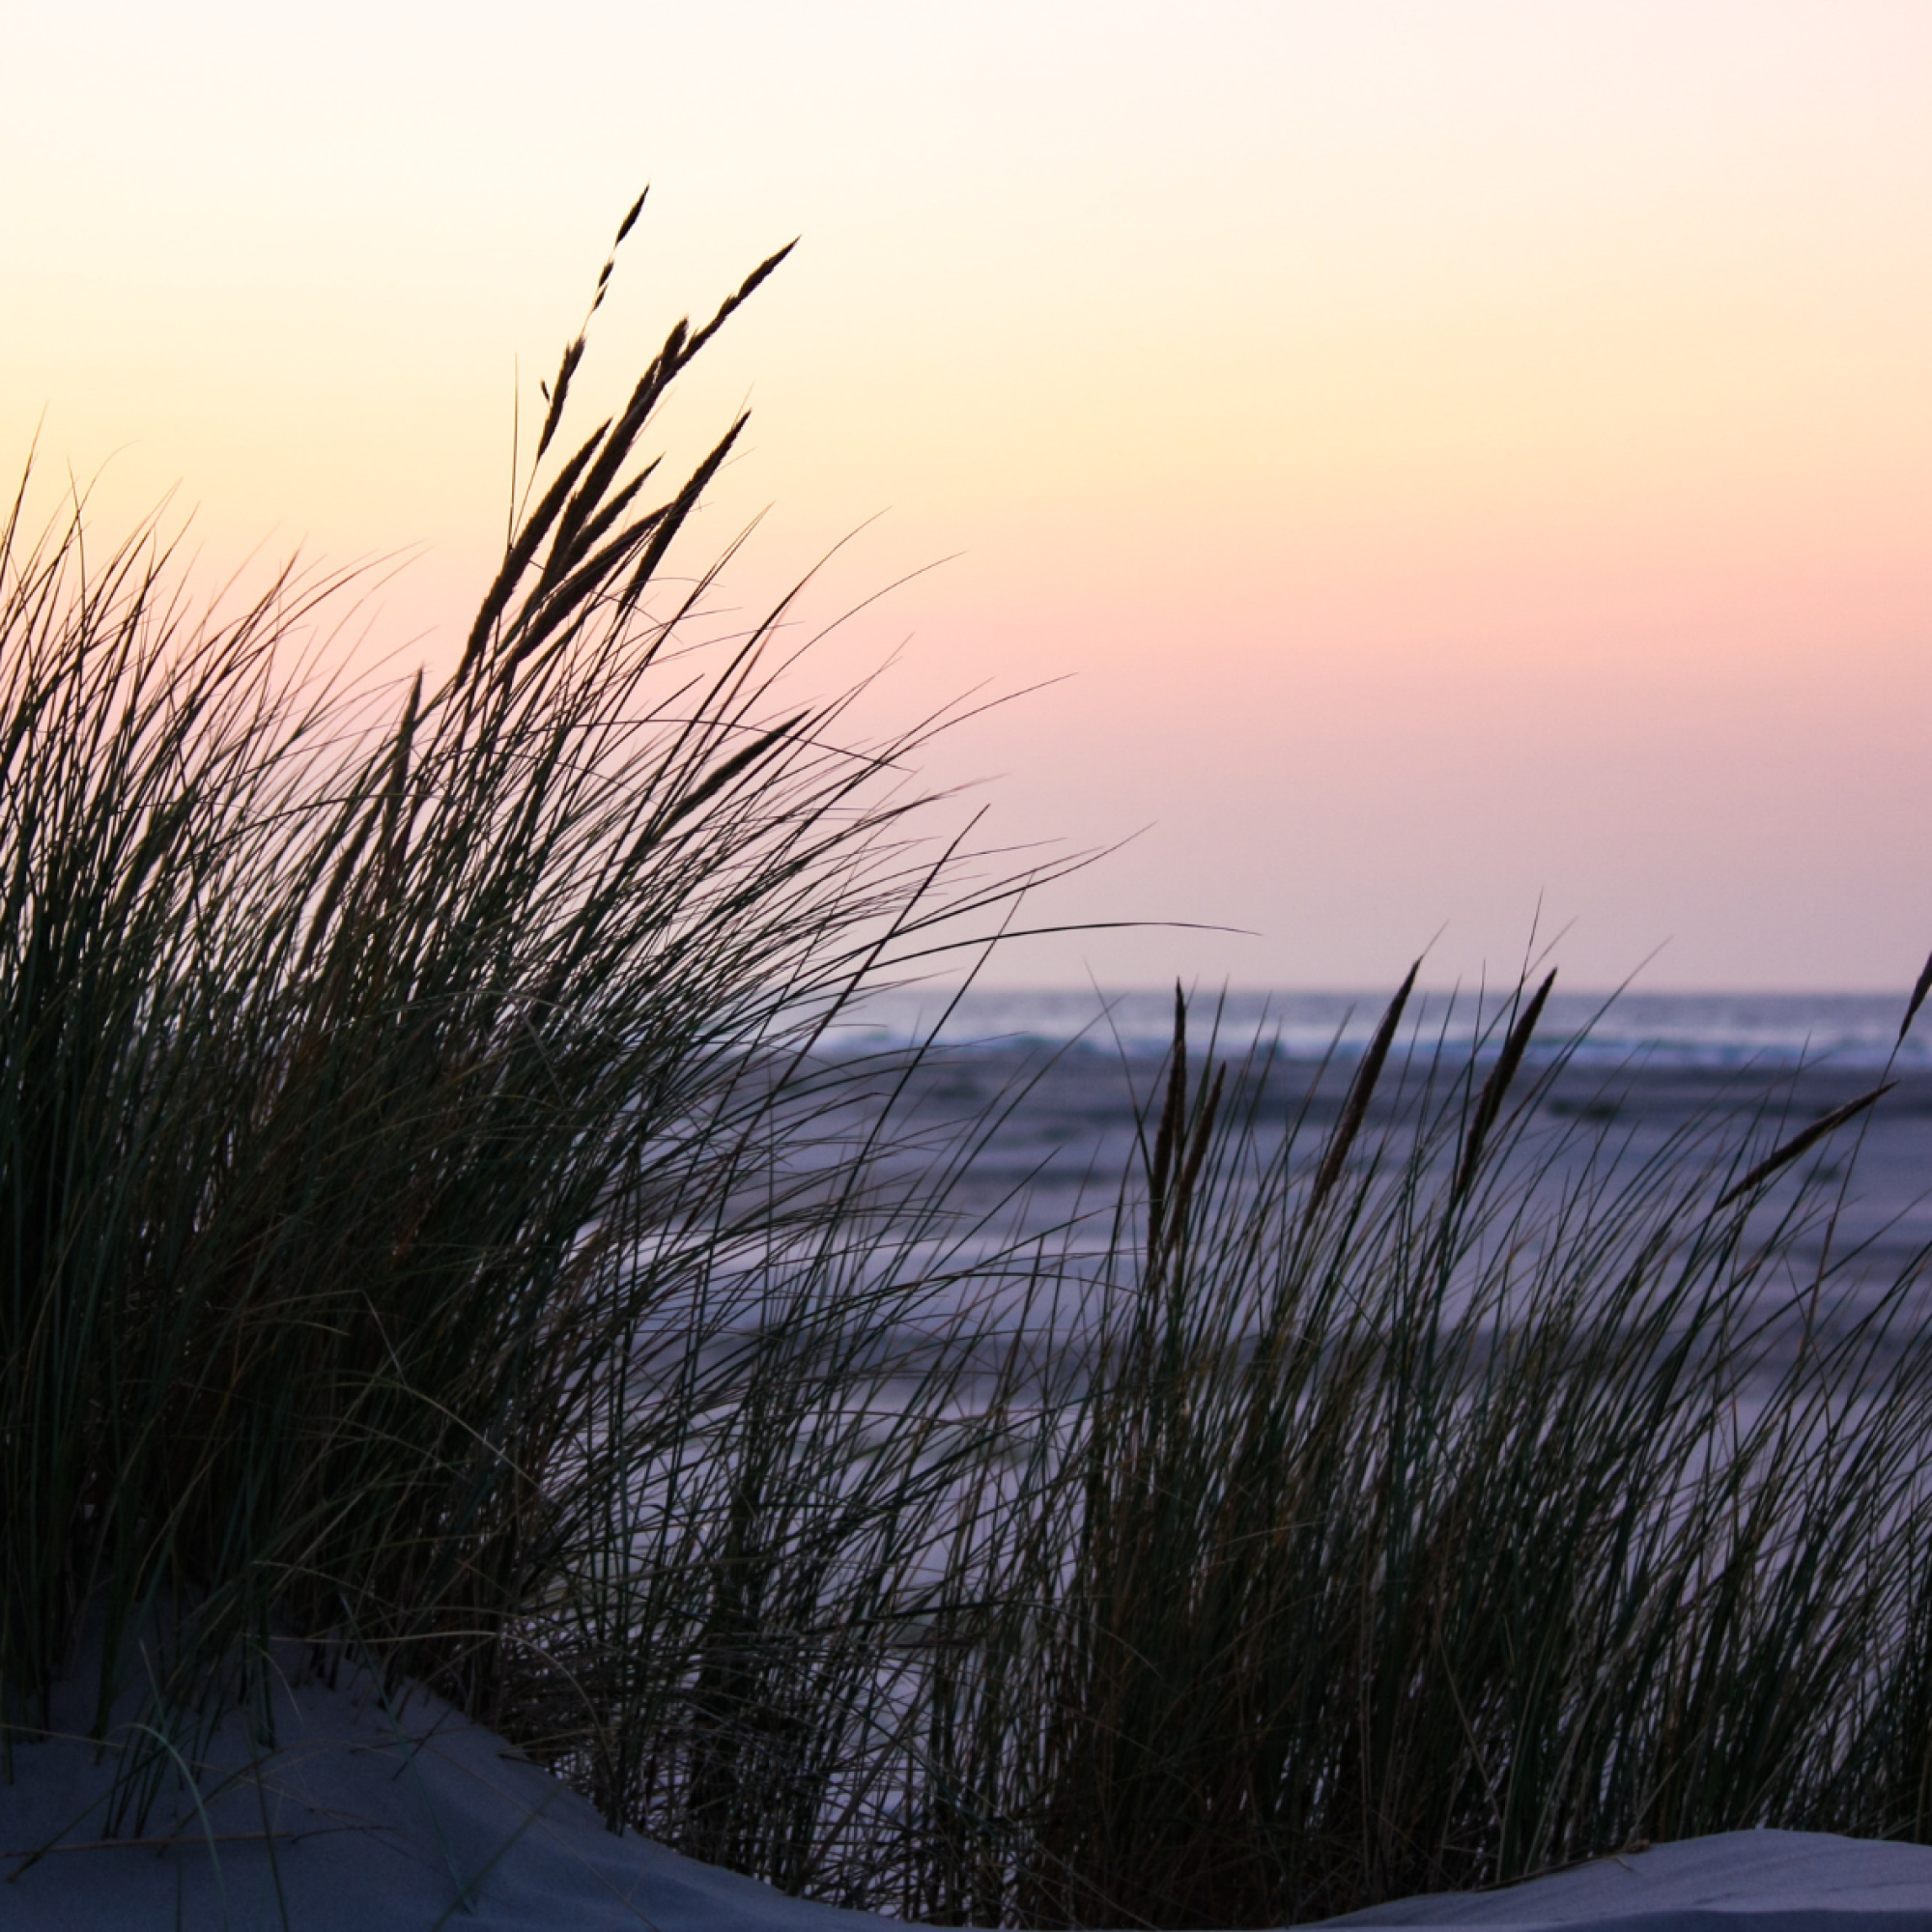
[[0, 209, 1059, 1803]]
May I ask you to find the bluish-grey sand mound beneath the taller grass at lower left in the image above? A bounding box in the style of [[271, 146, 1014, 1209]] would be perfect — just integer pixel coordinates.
[[0, 1662, 889, 1932]]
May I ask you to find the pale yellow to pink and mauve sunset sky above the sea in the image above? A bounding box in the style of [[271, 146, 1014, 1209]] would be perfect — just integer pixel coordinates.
[[0, 0, 1932, 989]]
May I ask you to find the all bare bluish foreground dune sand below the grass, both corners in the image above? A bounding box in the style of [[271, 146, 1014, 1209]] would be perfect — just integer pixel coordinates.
[[0, 1685, 1932, 1932]]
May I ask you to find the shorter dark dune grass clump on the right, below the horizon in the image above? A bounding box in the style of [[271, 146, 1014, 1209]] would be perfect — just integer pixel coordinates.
[[904, 983, 1932, 1926]]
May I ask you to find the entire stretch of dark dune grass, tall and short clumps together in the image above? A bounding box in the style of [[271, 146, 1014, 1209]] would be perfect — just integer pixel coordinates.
[[0, 209, 1932, 1926]]
